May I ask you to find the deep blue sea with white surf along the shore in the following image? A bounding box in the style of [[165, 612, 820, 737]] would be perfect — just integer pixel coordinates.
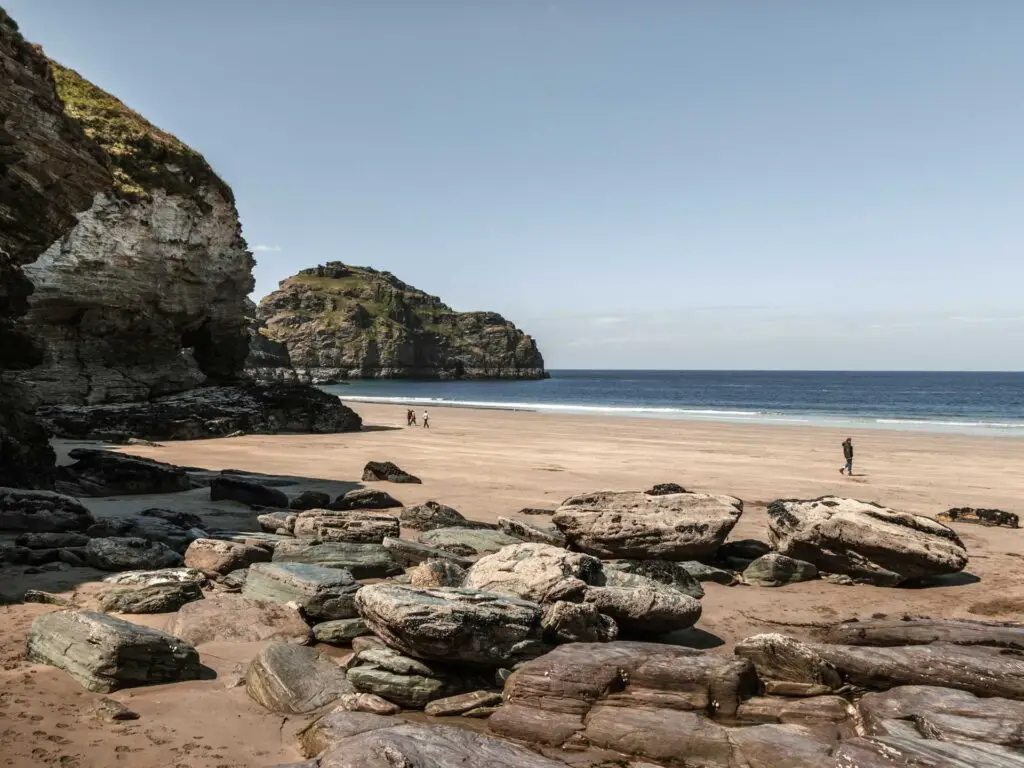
[[324, 371, 1024, 437]]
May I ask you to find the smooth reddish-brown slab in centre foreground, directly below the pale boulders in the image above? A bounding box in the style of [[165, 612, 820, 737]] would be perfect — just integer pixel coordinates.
[[488, 640, 758, 754]]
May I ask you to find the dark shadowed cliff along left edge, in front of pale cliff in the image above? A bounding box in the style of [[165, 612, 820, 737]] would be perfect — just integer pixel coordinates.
[[0, 8, 113, 487]]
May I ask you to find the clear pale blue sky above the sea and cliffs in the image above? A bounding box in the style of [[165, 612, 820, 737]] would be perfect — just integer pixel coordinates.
[[9, 0, 1024, 370]]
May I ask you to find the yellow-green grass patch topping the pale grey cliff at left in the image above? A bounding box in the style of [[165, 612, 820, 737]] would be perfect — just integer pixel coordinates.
[[50, 60, 233, 202]]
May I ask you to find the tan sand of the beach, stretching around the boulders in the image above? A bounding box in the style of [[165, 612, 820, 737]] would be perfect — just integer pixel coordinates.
[[0, 403, 1024, 768]]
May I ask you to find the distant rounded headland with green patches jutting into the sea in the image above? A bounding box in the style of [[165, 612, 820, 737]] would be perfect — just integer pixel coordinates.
[[247, 261, 547, 383]]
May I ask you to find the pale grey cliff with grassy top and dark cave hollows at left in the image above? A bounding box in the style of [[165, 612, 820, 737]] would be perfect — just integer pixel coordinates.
[[12, 57, 253, 404]]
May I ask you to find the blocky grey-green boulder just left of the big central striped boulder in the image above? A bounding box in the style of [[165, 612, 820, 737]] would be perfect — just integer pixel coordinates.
[[242, 562, 361, 624]]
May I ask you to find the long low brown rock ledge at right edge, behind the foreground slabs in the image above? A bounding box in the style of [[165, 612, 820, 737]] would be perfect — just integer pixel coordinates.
[[822, 616, 1024, 650]]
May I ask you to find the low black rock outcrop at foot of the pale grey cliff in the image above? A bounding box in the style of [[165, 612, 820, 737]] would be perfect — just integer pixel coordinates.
[[37, 383, 362, 441]]
